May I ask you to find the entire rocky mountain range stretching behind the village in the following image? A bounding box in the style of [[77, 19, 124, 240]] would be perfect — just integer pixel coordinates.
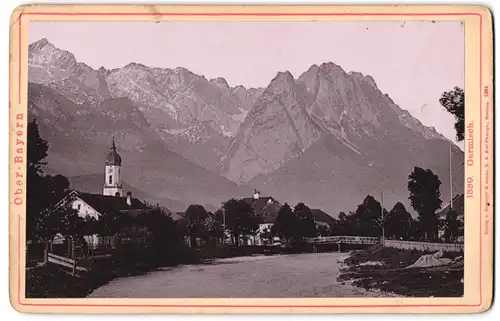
[[28, 39, 463, 216]]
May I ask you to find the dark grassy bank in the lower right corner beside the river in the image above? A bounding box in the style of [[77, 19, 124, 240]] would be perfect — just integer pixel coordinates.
[[338, 245, 464, 297]]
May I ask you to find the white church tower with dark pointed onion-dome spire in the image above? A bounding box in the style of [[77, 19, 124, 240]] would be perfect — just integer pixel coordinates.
[[102, 137, 123, 197]]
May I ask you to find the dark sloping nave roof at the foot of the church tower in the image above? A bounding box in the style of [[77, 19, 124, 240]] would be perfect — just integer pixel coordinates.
[[76, 192, 147, 214]]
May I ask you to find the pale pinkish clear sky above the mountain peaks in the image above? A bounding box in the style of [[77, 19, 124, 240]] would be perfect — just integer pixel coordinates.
[[28, 21, 465, 146]]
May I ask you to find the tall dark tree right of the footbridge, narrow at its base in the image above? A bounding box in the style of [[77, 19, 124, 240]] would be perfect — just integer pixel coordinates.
[[408, 167, 442, 240]]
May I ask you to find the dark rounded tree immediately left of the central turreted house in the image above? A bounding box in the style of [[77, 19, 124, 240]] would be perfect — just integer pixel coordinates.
[[223, 198, 259, 246]]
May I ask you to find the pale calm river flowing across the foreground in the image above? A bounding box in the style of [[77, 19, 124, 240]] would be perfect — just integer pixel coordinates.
[[89, 253, 392, 298]]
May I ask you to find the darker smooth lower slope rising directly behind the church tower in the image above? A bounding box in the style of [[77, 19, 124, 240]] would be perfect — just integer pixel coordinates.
[[28, 83, 251, 210]]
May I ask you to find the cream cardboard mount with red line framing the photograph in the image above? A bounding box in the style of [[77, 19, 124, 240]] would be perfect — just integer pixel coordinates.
[[9, 5, 493, 313]]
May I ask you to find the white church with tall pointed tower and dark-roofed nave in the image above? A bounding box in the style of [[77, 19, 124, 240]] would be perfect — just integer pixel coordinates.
[[56, 138, 147, 248]]
